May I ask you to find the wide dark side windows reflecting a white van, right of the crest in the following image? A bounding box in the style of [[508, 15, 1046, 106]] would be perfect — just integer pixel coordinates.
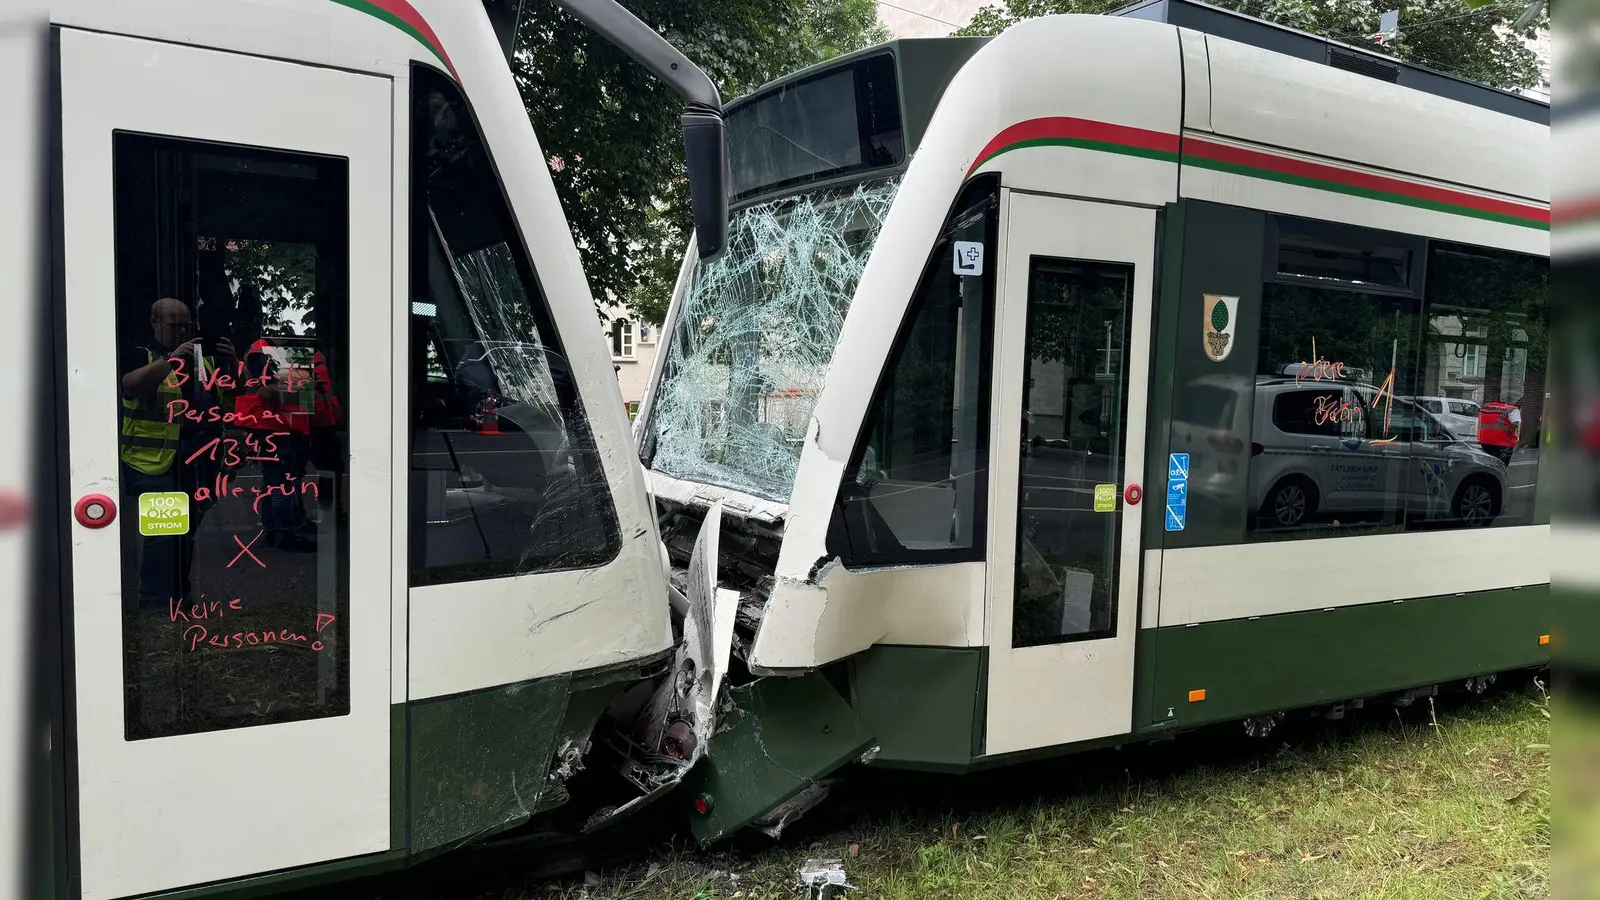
[[1250, 219, 1549, 540]]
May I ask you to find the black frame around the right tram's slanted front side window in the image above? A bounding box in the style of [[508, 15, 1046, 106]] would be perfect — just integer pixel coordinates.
[[827, 173, 1000, 570]]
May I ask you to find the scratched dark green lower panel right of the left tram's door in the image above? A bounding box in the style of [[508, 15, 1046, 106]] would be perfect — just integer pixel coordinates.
[[408, 674, 571, 854]]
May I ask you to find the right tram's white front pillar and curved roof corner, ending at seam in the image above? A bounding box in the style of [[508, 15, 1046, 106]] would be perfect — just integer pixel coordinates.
[[754, 16, 1182, 669]]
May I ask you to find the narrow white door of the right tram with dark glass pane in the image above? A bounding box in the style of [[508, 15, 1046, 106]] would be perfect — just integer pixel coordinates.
[[984, 192, 1155, 756]]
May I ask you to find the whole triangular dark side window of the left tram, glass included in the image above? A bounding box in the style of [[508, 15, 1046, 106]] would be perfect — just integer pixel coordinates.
[[410, 66, 621, 585]]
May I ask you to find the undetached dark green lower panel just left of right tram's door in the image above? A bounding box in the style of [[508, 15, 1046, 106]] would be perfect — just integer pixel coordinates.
[[850, 645, 984, 772]]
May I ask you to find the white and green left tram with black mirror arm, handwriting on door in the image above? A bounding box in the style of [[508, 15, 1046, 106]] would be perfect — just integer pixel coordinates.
[[39, 0, 726, 900]]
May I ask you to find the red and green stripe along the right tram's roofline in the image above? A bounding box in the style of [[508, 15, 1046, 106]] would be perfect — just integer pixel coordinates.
[[968, 117, 1550, 231]]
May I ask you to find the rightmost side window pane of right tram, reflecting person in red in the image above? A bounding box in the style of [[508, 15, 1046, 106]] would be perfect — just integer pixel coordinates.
[[1418, 242, 1550, 525]]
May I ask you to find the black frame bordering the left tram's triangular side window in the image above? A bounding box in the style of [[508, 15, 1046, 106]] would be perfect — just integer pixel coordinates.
[[405, 61, 622, 588]]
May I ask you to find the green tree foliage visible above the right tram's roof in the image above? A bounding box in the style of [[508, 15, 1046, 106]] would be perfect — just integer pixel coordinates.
[[957, 0, 1550, 90]]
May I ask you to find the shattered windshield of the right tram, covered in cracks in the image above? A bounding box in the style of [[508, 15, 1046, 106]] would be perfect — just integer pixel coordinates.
[[645, 179, 899, 503]]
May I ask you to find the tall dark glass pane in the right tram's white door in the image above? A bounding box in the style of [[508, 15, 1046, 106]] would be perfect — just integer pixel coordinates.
[[1011, 256, 1133, 647]]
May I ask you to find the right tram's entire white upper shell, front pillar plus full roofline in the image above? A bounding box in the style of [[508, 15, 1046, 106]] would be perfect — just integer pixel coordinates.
[[752, 16, 1550, 669]]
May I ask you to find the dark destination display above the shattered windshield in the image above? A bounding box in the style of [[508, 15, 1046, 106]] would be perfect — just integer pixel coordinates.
[[726, 53, 906, 200]]
